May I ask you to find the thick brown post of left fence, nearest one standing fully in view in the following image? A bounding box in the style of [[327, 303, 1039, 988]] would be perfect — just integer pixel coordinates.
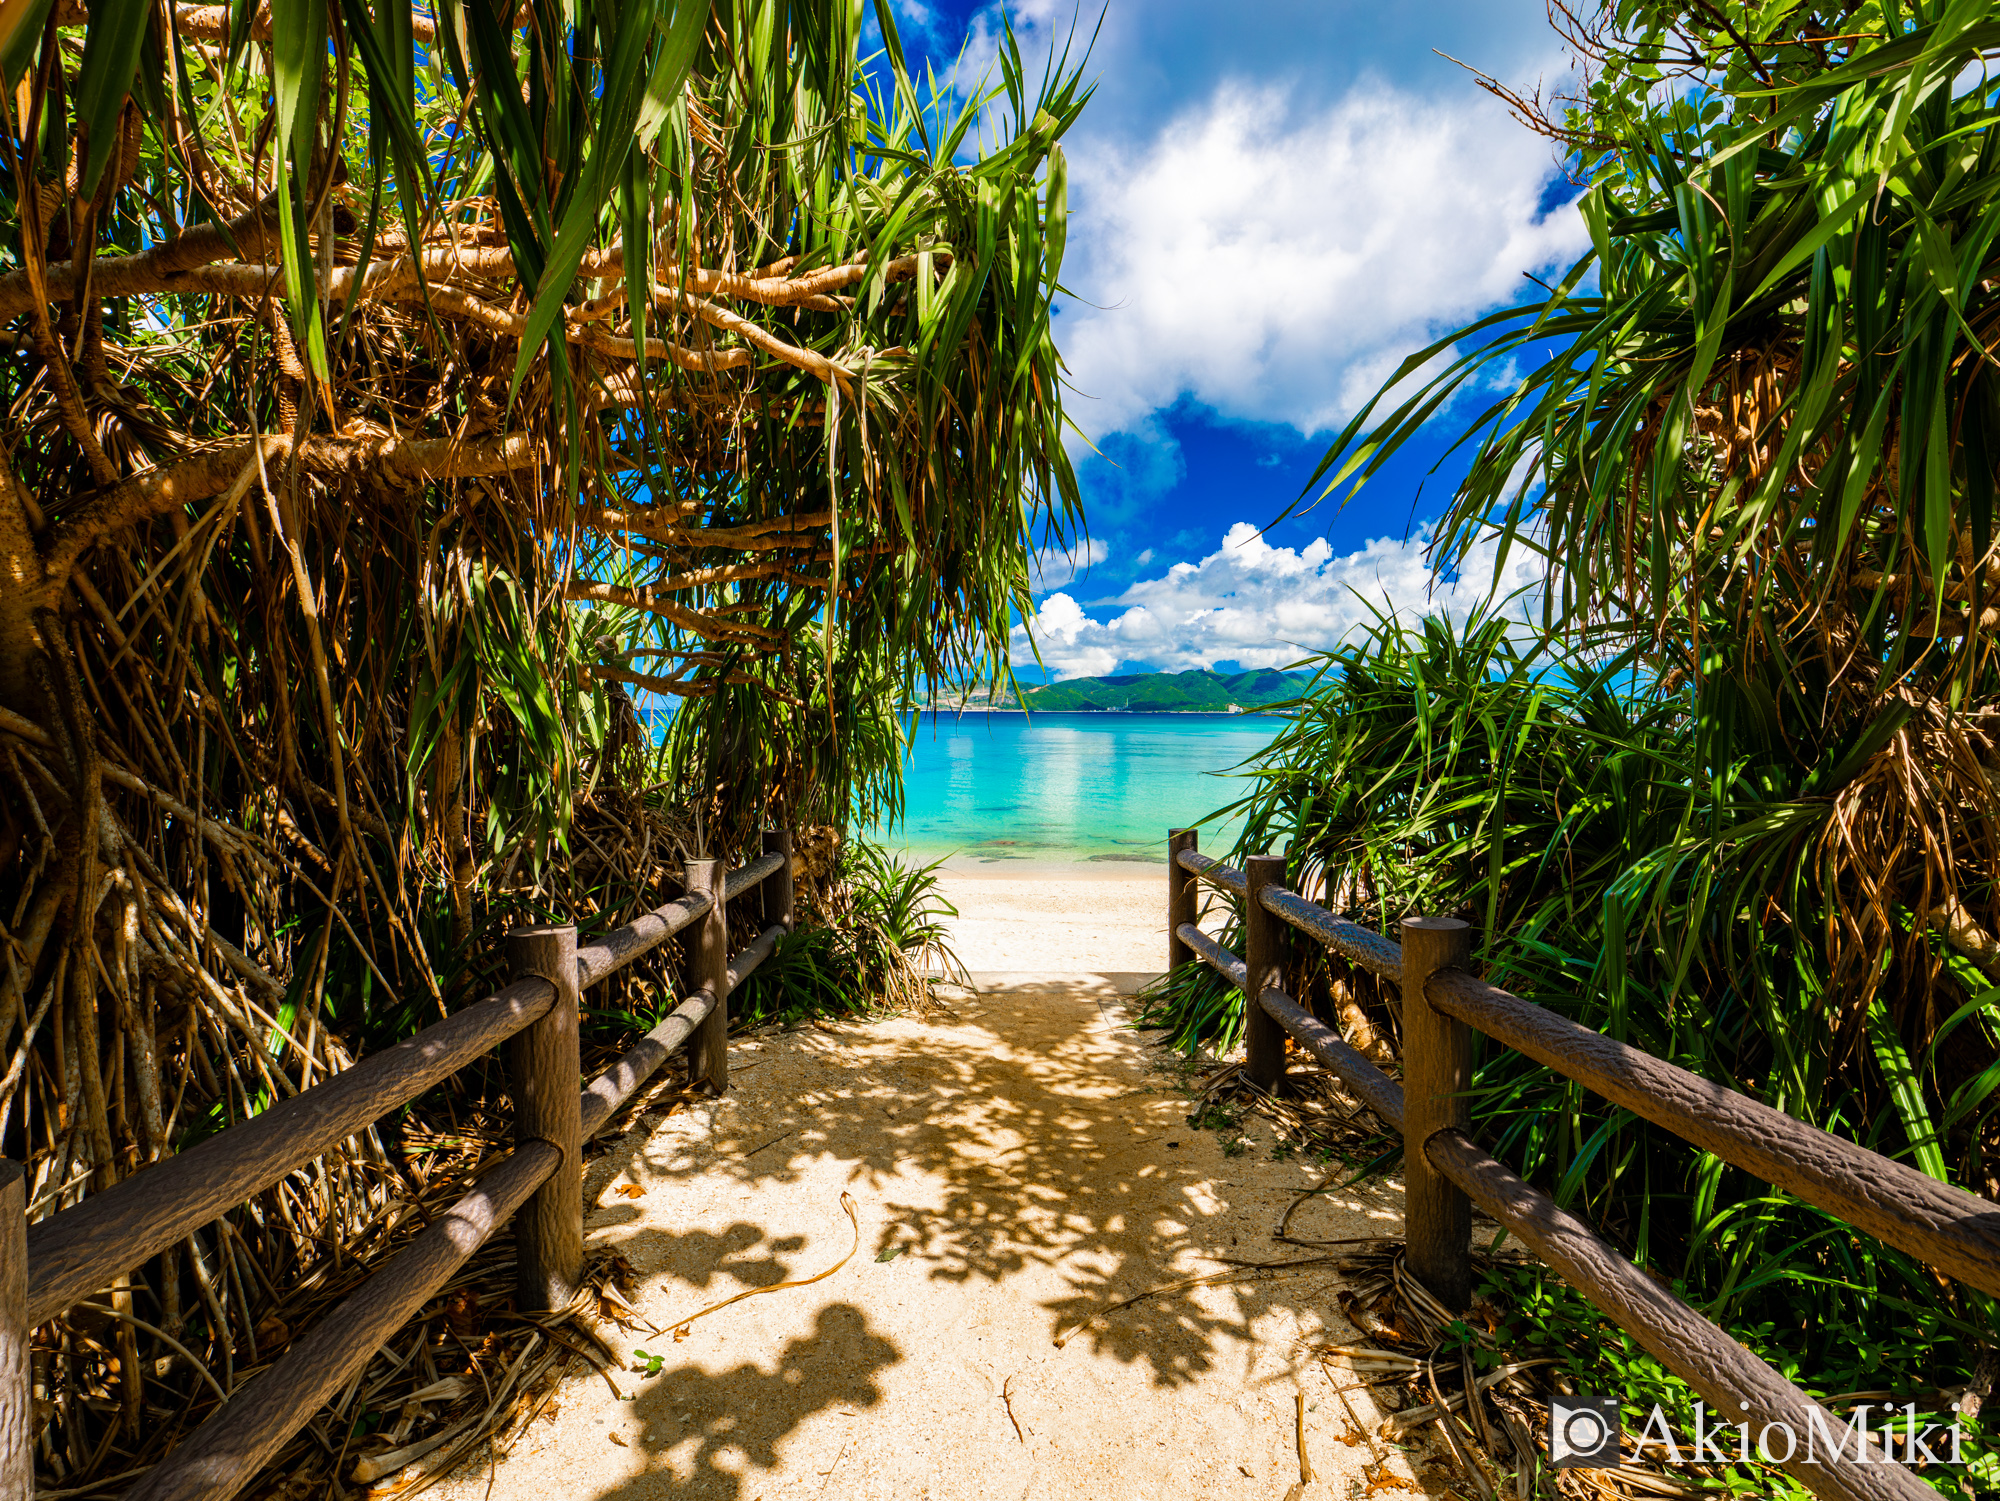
[[506, 927, 584, 1313]]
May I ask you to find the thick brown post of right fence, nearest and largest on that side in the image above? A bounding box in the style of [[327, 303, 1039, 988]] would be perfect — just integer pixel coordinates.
[[1402, 917, 1472, 1313]]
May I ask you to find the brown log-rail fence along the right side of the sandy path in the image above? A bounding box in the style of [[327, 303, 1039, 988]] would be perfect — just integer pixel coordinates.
[[1166, 829, 2000, 1501]]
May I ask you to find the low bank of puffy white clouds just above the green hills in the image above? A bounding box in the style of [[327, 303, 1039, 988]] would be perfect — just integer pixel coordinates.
[[1014, 522, 1540, 678]]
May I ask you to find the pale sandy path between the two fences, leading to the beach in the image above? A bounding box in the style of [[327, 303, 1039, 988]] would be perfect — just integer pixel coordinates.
[[440, 873, 1418, 1501]]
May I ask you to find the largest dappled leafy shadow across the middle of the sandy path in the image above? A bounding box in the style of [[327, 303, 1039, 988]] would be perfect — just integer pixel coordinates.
[[594, 983, 1398, 1387]]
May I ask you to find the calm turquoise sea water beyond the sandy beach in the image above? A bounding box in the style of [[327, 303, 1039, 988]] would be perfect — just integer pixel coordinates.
[[874, 712, 1282, 873]]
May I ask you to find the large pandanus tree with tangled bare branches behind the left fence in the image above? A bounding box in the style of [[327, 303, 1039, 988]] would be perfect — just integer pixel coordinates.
[[0, 0, 1088, 1471]]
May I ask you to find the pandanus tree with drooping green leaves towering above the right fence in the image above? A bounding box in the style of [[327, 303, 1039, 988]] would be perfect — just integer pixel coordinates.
[[1322, 0, 2000, 1128]]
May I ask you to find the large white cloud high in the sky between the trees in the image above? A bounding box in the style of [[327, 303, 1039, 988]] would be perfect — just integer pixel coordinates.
[[1058, 80, 1588, 436]]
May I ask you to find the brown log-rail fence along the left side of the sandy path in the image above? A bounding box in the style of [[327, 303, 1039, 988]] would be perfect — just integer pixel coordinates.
[[0, 831, 792, 1501]]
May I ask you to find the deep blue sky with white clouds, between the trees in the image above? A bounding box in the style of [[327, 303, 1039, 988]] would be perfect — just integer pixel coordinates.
[[894, 0, 1586, 678]]
